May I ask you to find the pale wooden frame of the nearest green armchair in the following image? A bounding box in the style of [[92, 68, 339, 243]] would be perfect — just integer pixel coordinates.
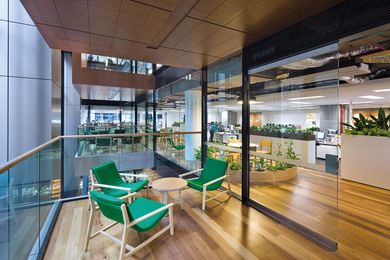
[[84, 192, 174, 260]]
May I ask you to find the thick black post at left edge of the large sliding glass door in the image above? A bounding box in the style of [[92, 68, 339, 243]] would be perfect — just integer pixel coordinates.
[[241, 68, 250, 203]]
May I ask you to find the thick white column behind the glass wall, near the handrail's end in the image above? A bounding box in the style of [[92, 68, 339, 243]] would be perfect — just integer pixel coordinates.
[[184, 90, 202, 161]]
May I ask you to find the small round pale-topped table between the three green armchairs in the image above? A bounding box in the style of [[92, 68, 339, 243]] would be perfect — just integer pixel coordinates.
[[152, 177, 187, 209]]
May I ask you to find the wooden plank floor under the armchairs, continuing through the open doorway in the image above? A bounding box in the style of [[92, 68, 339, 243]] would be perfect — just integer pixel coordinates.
[[44, 171, 390, 260]]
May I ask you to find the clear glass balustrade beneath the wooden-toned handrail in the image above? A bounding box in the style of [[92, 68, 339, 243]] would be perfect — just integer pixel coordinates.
[[0, 132, 201, 259]]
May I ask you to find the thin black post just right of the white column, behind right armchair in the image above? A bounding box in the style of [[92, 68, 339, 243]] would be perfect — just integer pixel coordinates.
[[201, 66, 208, 167]]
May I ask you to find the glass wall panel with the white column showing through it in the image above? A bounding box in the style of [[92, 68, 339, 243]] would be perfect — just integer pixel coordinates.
[[156, 71, 202, 170]]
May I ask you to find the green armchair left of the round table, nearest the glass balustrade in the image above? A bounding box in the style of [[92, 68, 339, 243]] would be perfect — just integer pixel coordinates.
[[90, 161, 149, 199]]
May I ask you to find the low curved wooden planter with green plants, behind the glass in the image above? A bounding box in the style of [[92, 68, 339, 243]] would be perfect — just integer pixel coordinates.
[[229, 167, 297, 183]]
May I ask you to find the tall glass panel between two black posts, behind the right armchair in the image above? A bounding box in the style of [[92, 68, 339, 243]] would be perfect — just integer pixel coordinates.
[[207, 54, 242, 197]]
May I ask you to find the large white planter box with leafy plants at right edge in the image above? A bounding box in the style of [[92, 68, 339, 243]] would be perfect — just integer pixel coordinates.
[[340, 135, 390, 189]]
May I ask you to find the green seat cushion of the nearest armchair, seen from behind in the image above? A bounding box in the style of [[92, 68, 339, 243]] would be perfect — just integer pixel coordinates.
[[127, 198, 168, 232]]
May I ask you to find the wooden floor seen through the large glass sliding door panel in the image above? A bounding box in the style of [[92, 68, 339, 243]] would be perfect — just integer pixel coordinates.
[[232, 168, 338, 241]]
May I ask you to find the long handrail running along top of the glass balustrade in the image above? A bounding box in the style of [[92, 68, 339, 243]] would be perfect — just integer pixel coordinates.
[[0, 131, 202, 174]]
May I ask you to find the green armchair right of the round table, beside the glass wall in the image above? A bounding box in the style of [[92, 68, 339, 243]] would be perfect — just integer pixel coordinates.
[[179, 158, 231, 210]]
